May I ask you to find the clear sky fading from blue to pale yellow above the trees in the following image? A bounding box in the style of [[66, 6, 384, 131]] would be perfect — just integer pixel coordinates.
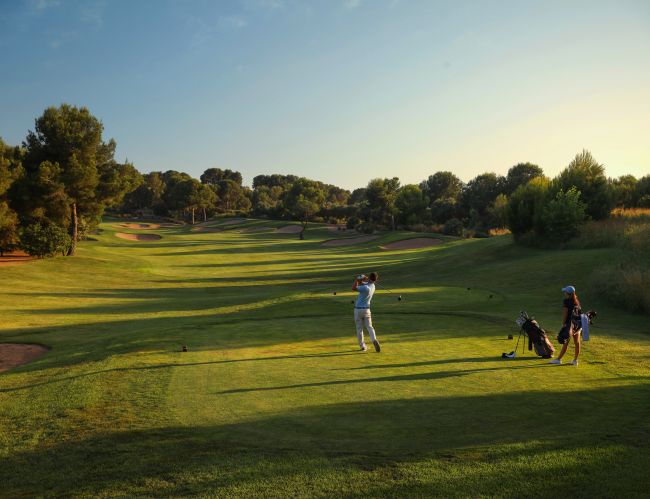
[[0, 0, 650, 188]]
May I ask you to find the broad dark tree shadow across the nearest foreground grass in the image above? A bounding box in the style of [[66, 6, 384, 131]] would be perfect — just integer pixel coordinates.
[[0, 385, 650, 497]]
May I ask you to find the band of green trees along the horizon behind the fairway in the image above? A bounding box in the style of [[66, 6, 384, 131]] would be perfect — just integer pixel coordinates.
[[0, 104, 650, 256]]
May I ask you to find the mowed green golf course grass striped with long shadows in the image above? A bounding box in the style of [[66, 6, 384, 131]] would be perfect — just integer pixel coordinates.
[[0, 220, 650, 497]]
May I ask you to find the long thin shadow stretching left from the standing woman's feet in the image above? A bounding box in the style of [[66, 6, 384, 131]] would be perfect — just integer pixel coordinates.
[[215, 364, 546, 395]]
